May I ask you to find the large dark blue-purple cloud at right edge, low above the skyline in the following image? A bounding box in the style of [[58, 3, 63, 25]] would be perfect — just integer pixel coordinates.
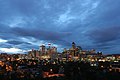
[[88, 26, 120, 53]]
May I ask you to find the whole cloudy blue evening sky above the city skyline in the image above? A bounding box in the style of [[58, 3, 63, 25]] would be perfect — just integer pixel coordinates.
[[0, 0, 120, 54]]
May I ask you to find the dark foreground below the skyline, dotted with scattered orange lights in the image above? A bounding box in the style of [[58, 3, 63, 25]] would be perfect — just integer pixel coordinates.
[[0, 60, 120, 80]]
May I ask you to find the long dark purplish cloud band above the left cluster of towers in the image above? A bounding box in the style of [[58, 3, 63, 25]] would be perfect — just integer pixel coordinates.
[[12, 28, 70, 40]]
